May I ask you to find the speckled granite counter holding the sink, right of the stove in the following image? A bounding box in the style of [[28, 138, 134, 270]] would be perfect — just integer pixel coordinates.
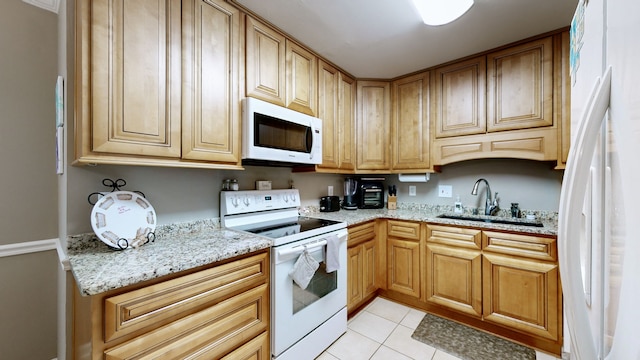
[[302, 204, 558, 236]]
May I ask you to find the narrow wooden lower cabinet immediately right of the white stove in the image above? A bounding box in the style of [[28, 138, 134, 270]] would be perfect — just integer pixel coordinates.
[[347, 221, 379, 312]]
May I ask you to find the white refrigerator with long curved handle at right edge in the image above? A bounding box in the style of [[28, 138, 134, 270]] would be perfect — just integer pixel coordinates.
[[558, 0, 640, 360]]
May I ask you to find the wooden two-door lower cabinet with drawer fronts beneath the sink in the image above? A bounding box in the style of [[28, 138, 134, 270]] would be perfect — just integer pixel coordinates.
[[422, 224, 562, 354]]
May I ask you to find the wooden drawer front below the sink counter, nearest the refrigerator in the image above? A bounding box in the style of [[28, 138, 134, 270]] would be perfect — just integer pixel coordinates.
[[482, 231, 558, 261]]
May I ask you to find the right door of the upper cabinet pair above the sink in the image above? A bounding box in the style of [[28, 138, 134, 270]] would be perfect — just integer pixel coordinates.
[[487, 37, 553, 132]]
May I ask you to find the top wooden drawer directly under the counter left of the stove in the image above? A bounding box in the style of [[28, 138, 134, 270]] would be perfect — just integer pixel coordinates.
[[104, 253, 269, 342]]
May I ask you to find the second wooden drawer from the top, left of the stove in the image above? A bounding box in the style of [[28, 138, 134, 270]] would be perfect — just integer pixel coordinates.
[[105, 284, 269, 360]]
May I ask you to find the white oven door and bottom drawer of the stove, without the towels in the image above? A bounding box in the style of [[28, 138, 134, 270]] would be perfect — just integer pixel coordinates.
[[271, 229, 347, 356]]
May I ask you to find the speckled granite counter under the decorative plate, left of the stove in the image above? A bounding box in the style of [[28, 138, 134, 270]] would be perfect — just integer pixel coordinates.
[[67, 220, 271, 295]]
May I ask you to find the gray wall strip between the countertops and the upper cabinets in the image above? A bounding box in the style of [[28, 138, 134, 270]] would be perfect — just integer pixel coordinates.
[[67, 160, 562, 234]]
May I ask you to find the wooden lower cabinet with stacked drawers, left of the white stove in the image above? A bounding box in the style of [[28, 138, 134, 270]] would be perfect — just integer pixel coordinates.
[[74, 251, 270, 359]]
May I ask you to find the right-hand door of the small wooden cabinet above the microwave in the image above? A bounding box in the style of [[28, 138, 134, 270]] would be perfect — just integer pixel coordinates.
[[285, 40, 318, 116]]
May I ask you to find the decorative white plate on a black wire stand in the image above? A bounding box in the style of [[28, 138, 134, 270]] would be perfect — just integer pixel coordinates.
[[91, 191, 156, 249]]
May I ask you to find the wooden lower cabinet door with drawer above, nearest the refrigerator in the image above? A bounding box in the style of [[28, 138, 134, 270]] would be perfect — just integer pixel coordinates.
[[482, 231, 562, 340]]
